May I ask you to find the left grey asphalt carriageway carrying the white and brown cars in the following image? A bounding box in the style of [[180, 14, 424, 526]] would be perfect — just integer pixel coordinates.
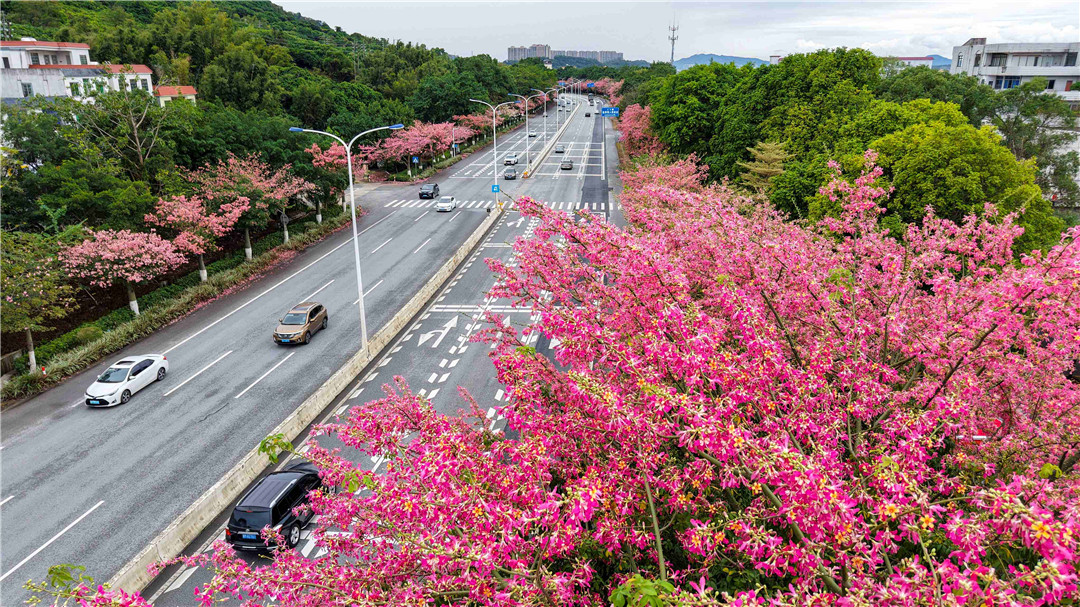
[[0, 98, 572, 605]]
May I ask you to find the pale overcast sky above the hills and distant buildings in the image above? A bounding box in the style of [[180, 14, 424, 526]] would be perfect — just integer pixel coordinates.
[[278, 0, 1080, 60]]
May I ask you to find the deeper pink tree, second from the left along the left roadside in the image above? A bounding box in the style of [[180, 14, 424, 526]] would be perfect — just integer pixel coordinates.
[[145, 195, 251, 282]]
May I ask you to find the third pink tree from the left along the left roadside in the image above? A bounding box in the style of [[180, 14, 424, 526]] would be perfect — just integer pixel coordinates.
[[188, 152, 315, 254]]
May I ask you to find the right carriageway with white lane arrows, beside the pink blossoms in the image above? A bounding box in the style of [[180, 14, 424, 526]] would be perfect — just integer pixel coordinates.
[[145, 94, 623, 607]]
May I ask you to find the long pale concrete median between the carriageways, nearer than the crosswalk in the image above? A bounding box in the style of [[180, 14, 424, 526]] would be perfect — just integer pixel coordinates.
[[109, 205, 502, 592]]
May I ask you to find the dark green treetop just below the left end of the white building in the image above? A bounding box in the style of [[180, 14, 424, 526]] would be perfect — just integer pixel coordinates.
[[876, 66, 995, 126]]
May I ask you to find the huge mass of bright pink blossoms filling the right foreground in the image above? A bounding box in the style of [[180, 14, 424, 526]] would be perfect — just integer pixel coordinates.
[[35, 153, 1080, 607]]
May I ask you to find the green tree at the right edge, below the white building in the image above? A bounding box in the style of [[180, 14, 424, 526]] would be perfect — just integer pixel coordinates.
[[990, 78, 1080, 206]]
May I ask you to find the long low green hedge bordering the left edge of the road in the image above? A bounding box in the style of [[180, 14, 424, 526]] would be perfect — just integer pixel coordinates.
[[0, 205, 349, 399]]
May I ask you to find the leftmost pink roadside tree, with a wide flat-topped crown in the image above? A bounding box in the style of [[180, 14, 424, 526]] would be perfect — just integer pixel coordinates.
[[60, 230, 185, 316]]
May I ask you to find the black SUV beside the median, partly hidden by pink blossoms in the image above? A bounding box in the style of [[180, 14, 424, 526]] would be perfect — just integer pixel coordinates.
[[225, 461, 323, 551]]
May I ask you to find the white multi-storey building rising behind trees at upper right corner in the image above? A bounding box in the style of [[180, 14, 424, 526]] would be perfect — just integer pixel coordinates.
[[949, 38, 1080, 107]]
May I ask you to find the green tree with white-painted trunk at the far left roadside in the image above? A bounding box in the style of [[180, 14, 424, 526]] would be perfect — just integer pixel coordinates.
[[0, 230, 76, 373]]
